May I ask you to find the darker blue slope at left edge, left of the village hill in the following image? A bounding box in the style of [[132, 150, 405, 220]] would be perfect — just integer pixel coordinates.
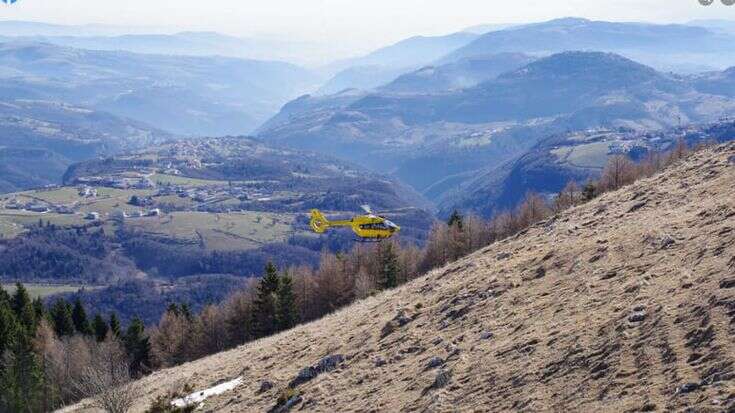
[[0, 100, 171, 192]]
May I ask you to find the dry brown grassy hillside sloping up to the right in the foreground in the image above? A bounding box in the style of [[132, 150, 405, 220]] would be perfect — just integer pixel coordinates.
[[69, 144, 735, 412]]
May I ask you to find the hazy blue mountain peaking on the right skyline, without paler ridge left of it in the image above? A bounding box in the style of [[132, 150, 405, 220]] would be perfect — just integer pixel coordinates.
[[441, 18, 735, 70]]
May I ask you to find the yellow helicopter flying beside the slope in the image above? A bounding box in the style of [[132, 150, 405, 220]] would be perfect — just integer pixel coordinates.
[[310, 205, 401, 242]]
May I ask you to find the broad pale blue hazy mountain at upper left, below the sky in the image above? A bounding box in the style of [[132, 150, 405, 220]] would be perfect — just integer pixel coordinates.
[[0, 42, 316, 135]]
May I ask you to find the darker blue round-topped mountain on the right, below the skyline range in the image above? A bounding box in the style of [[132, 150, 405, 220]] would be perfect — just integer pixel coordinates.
[[260, 52, 735, 211]]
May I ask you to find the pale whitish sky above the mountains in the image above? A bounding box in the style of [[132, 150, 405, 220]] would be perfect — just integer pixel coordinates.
[[0, 0, 735, 51]]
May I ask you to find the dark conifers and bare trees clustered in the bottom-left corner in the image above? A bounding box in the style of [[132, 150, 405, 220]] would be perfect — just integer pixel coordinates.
[[0, 283, 152, 412]]
